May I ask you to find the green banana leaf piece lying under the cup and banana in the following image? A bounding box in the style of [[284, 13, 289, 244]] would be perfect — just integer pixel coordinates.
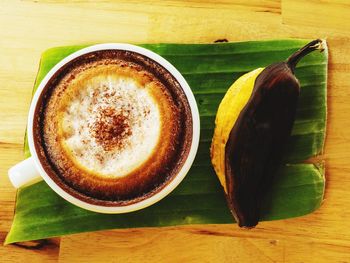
[[5, 40, 328, 244]]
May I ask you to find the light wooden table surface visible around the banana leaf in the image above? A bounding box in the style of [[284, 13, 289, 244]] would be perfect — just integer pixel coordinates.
[[0, 0, 350, 262]]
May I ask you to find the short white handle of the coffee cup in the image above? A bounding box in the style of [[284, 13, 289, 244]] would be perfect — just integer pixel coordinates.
[[8, 157, 42, 188]]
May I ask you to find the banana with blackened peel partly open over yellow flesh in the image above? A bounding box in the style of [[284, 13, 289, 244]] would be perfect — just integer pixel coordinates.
[[211, 39, 326, 228]]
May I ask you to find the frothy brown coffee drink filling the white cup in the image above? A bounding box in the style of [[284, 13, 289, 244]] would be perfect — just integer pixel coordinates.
[[33, 50, 192, 206]]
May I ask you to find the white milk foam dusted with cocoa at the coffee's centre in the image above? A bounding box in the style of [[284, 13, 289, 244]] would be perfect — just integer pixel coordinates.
[[62, 72, 161, 178]]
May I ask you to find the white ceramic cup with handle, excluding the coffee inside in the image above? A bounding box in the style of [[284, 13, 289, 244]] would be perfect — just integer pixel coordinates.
[[8, 43, 200, 214]]
